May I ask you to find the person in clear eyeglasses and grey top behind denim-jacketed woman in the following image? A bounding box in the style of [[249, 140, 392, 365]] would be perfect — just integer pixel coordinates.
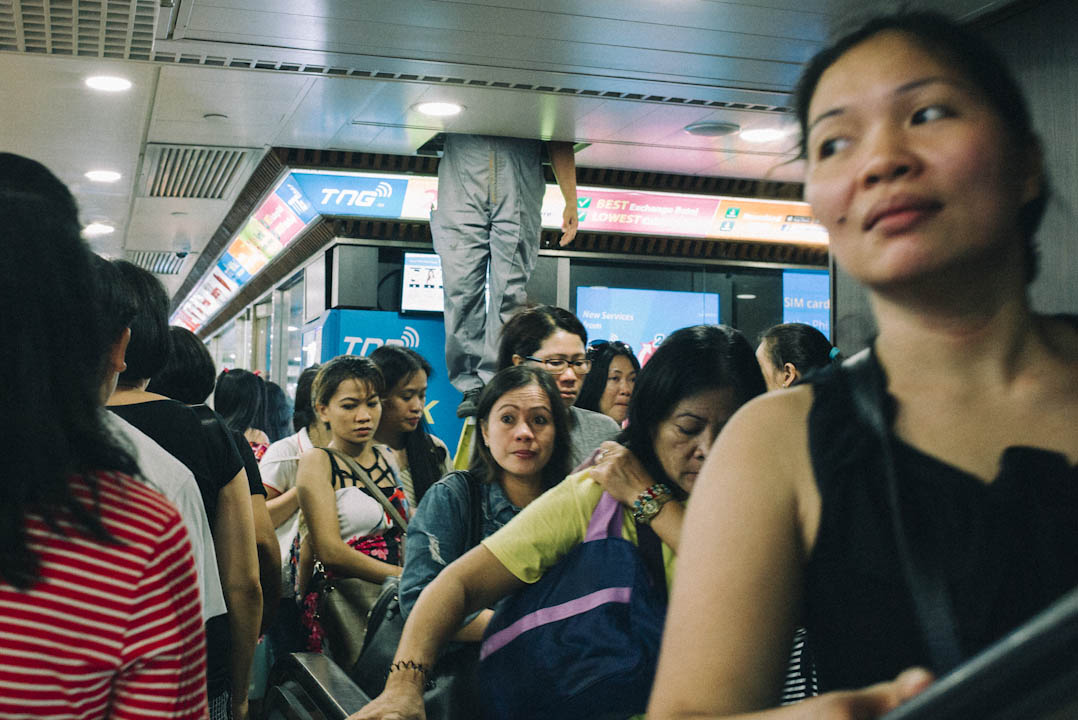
[[498, 305, 620, 468]]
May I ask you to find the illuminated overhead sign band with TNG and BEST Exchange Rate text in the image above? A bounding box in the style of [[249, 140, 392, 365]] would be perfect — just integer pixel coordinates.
[[172, 169, 828, 330]]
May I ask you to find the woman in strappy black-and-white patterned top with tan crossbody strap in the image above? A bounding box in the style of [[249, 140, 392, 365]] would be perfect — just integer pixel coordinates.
[[293, 355, 409, 652]]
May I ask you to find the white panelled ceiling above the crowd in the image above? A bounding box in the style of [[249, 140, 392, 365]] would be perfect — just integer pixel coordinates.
[[0, 0, 1007, 292]]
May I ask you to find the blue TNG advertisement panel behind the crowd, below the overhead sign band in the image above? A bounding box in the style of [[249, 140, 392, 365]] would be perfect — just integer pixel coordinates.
[[321, 309, 464, 454]]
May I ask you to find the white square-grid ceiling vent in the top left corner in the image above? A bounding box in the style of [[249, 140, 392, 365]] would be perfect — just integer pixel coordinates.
[[0, 0, 157, 60]]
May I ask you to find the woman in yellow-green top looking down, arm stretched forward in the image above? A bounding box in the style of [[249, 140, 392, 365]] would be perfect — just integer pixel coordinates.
[[350, 326, 764, 720]]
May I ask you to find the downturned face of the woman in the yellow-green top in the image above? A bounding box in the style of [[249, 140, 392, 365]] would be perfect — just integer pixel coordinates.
[[652, 387, 738, 493]]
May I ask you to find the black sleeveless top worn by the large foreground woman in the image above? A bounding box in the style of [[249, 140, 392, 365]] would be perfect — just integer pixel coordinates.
[[803, 359, 1078, 692]]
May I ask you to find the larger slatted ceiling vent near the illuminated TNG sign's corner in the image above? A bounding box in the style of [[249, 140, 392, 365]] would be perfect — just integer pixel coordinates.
[[143, 144, 252, 200]]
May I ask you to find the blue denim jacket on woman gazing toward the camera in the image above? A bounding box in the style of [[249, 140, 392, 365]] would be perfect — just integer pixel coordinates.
[[400, 472, 521, 624]]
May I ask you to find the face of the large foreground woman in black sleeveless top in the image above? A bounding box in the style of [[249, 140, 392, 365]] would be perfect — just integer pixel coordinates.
[[805, 31, 1040, 288]]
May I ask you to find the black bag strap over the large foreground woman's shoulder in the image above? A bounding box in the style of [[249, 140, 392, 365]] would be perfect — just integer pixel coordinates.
[[842, 347, 963, 675]]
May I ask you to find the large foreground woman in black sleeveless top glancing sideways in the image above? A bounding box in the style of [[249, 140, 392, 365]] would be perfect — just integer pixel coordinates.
[[649, 14, 1078, 719]]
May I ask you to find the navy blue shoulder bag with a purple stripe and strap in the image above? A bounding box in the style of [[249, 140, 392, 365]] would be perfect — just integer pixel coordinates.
[[480, 493, 666, 720]]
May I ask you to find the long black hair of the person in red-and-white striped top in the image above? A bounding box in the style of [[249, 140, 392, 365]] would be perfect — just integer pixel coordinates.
[[0, 153, 138, 589]]
